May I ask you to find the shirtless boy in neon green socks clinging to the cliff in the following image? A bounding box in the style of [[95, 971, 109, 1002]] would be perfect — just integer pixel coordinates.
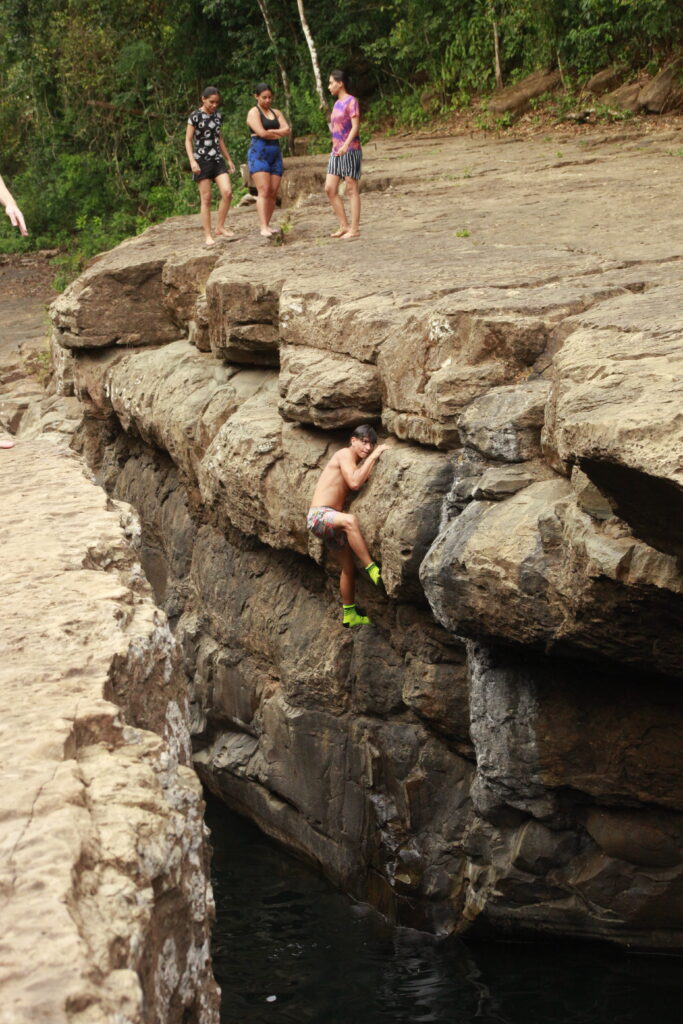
[[306, 424, 389, 627]]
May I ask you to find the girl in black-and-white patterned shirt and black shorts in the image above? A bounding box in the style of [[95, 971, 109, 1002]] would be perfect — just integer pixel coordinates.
[[185, 85, 234, 246]]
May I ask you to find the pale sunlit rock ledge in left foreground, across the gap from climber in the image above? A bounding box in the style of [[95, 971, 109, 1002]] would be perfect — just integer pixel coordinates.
[[0, 438, 218, 1024]]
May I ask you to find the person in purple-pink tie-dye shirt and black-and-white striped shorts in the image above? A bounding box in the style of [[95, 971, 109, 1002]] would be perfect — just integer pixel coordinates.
[[325, 68, 362, 242]]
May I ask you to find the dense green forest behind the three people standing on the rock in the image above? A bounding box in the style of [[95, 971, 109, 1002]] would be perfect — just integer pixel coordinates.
[[0, 0, 683, 269]]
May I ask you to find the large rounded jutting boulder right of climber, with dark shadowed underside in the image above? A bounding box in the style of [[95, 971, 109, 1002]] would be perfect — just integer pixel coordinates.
[[420, 479, 683, 676]]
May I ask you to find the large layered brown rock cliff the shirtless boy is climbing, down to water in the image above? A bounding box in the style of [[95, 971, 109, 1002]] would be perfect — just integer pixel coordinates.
[[56, 128, 683, 948]]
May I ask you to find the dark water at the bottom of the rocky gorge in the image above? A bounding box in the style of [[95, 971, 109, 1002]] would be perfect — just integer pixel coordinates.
[[207, 798, 683, 1024]]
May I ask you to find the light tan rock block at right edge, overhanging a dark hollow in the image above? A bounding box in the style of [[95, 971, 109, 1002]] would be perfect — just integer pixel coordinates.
[[544, 319, 683, 554]]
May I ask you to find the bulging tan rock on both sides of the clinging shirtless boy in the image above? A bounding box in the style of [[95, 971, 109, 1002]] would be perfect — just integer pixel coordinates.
[[199, 409, 452, 600]]
